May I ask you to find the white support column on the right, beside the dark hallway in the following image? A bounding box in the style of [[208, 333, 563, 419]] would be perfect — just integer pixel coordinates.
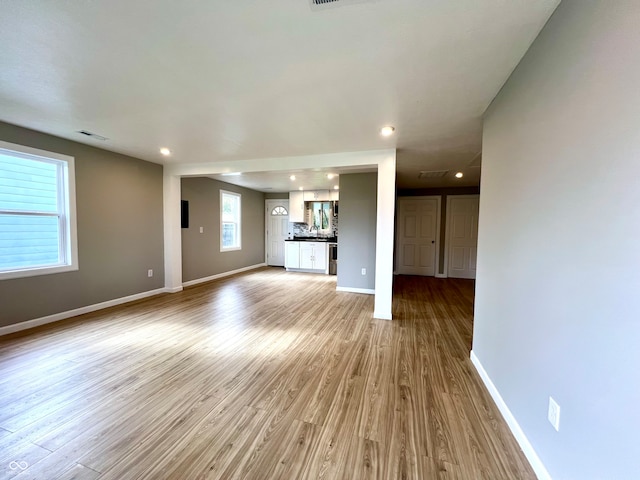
[[373, 151, 396, 320]]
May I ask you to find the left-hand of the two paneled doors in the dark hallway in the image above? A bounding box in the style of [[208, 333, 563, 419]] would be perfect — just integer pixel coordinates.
[[396, 197, 440, 276]]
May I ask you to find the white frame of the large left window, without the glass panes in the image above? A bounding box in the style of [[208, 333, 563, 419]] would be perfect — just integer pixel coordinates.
[[0, 141, 79, 280]]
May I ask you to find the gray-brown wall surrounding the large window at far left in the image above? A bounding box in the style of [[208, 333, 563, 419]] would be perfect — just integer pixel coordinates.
[[0, 123, 164, 326]]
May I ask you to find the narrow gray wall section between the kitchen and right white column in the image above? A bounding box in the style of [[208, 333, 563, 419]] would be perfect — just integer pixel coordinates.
[[337, 173, 378, 290]]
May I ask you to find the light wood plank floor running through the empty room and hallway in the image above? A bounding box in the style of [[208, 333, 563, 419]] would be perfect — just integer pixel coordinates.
[[0, 268, 535, 480]]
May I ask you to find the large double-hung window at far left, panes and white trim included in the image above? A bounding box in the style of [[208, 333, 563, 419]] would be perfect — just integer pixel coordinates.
[[0, 141, 78, 280]]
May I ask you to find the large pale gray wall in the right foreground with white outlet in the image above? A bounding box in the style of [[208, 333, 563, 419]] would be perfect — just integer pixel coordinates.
[[473, 0, 640, 480]]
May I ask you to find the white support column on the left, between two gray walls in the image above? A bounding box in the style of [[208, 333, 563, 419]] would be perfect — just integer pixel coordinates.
[[163, 172, 182, 293]]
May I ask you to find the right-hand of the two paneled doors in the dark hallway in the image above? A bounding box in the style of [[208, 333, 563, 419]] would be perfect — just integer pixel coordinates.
[[447, 195, 480, 278]]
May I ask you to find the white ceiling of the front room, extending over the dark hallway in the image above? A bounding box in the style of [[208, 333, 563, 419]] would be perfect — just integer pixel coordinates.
[[0, 0, 559, 190]]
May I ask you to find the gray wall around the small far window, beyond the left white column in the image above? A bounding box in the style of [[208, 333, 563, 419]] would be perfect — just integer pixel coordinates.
[[182, 178, 264, 282]]
